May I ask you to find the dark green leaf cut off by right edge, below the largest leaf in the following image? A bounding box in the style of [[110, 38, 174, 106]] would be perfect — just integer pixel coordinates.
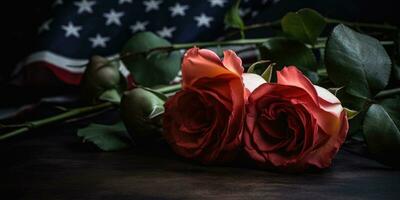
[[363, 100, 400, 167]]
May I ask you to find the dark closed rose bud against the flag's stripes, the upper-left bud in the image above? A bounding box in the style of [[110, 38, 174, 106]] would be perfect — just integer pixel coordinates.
[[81, 56, 126, 103]]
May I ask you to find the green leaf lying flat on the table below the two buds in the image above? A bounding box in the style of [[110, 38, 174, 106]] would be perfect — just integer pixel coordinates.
[[77, 122, 131, 151]]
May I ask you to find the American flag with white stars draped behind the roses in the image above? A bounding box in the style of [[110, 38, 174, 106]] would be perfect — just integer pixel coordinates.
[[16, 0, 278, 85]]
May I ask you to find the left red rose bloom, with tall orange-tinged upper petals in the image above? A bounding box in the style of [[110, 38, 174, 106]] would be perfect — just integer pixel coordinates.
[[163, 48, 245, 163]]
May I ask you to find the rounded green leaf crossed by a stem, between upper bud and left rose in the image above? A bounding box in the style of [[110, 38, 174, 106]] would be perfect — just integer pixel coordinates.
[[121, 32, 181, 87]]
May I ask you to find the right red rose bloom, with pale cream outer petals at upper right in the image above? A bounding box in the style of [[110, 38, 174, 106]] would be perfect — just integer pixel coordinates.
[[243, 66, 348, 171]]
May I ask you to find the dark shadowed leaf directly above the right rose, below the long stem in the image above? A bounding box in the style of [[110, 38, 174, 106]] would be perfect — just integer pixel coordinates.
[[259, 37, 317, 72]]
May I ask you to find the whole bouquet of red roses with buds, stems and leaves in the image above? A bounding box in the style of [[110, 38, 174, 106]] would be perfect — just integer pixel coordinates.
[[0, 4, 400, 172]]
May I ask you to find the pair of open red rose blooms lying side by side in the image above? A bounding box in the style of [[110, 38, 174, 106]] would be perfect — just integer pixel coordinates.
[[164, 48, 348, 171]]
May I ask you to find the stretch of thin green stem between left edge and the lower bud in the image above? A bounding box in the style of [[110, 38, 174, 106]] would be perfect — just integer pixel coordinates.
[[0, 102, 115, 140]]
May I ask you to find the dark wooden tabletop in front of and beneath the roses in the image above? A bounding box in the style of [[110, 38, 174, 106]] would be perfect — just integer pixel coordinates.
[[0, 124, 400, 200]]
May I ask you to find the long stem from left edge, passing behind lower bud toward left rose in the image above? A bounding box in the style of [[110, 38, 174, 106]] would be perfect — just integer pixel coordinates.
[[0, 83, 181, 140]]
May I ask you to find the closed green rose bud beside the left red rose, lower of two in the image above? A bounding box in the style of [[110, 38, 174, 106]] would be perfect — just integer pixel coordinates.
[[121, 88, 164, 139]]
